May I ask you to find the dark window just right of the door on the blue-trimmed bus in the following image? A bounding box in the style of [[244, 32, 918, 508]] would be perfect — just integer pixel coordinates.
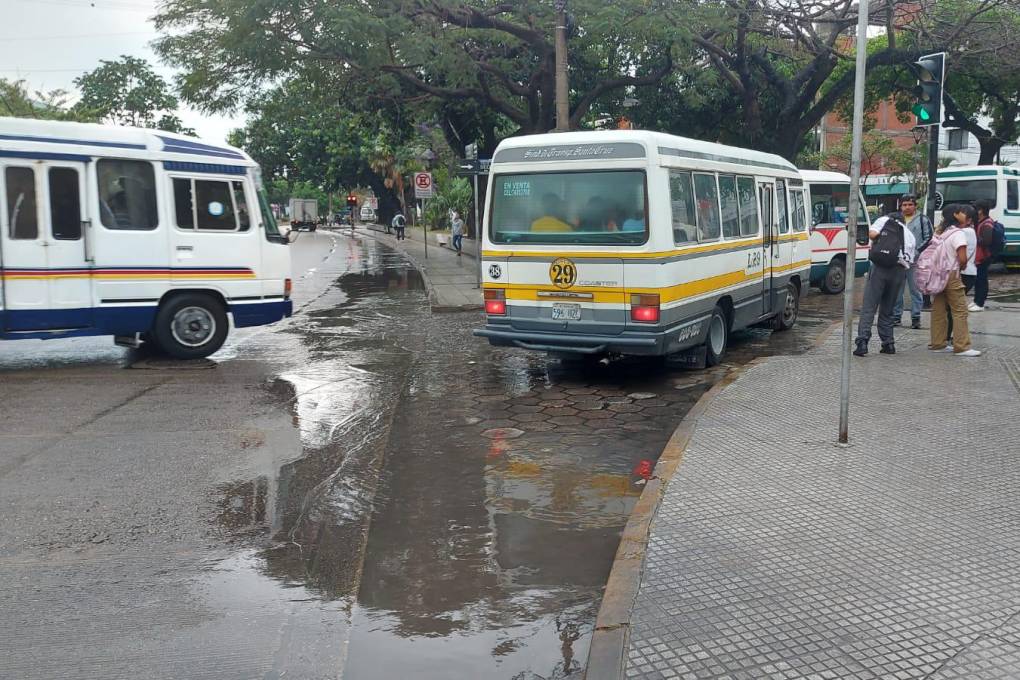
[[96, 158, 159, 231]]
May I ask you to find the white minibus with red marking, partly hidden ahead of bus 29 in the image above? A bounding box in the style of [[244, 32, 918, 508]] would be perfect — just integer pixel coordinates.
[[801, 170, 870, 294]]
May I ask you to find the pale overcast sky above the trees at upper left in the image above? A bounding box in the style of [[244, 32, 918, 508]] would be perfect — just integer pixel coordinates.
[[0, 0, 244, 142]]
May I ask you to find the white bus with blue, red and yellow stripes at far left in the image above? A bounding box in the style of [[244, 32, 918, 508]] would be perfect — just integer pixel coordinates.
[[0, 118, 292, 358]]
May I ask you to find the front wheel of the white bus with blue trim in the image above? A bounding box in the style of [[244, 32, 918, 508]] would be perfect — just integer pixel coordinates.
[[151, 293, 230, 359]]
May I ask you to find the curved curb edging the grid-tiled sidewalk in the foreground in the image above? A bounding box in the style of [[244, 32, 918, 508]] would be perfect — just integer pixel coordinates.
[[582, 319, 843, 680]]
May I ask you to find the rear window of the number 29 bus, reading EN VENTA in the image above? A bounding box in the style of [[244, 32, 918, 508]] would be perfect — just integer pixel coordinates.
[[490, 170, 648, 246]]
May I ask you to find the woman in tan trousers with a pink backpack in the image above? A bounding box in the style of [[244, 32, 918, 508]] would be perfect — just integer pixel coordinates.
[[915, 206, 981, 357]]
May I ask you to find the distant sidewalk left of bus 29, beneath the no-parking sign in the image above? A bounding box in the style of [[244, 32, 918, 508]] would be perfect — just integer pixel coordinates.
[[361, 224, 483, 312]]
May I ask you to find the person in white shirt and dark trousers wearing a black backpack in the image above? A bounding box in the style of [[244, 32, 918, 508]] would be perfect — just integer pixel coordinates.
[[854, 212, 916, 357]]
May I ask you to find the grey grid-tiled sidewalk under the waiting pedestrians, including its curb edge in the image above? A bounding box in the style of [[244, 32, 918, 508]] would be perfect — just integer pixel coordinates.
[[587, 304, 1020, 680]]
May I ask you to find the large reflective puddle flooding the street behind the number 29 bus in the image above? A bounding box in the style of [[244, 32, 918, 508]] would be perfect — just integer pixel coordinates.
[[205, 235, 844, 679]]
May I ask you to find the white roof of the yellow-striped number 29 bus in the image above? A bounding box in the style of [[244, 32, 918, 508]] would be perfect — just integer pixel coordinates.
[[493, 129, 797, 172]]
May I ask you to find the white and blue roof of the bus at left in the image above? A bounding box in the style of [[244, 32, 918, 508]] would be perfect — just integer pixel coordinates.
[[0, 117, 255, 165]]
